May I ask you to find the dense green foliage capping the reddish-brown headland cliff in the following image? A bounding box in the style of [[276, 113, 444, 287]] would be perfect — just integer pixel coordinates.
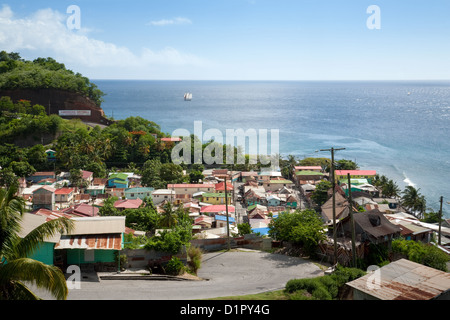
[[0, 51, 104, 106]]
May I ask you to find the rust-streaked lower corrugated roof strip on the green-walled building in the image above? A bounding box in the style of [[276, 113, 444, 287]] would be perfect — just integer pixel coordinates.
[[55, 233, 122, 250]]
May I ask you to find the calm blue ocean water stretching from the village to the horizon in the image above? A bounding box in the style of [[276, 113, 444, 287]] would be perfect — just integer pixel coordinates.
[[94, 80, 450, 217]]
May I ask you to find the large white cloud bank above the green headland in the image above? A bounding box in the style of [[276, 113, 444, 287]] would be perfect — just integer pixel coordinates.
[[0, 5, 208, 77]]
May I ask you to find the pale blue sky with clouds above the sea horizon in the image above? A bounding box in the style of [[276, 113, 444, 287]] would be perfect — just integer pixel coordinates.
[[0, 0, 450, 80]]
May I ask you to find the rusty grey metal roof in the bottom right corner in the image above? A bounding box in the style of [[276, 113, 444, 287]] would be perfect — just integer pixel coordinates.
[[347, 259, 450, 300]]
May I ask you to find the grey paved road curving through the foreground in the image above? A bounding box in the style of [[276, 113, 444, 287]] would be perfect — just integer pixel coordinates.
[[58, 251, 323, 300]]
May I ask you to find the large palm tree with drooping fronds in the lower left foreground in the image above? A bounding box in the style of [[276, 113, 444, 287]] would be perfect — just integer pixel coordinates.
[[0, 187, 73, 300]]
